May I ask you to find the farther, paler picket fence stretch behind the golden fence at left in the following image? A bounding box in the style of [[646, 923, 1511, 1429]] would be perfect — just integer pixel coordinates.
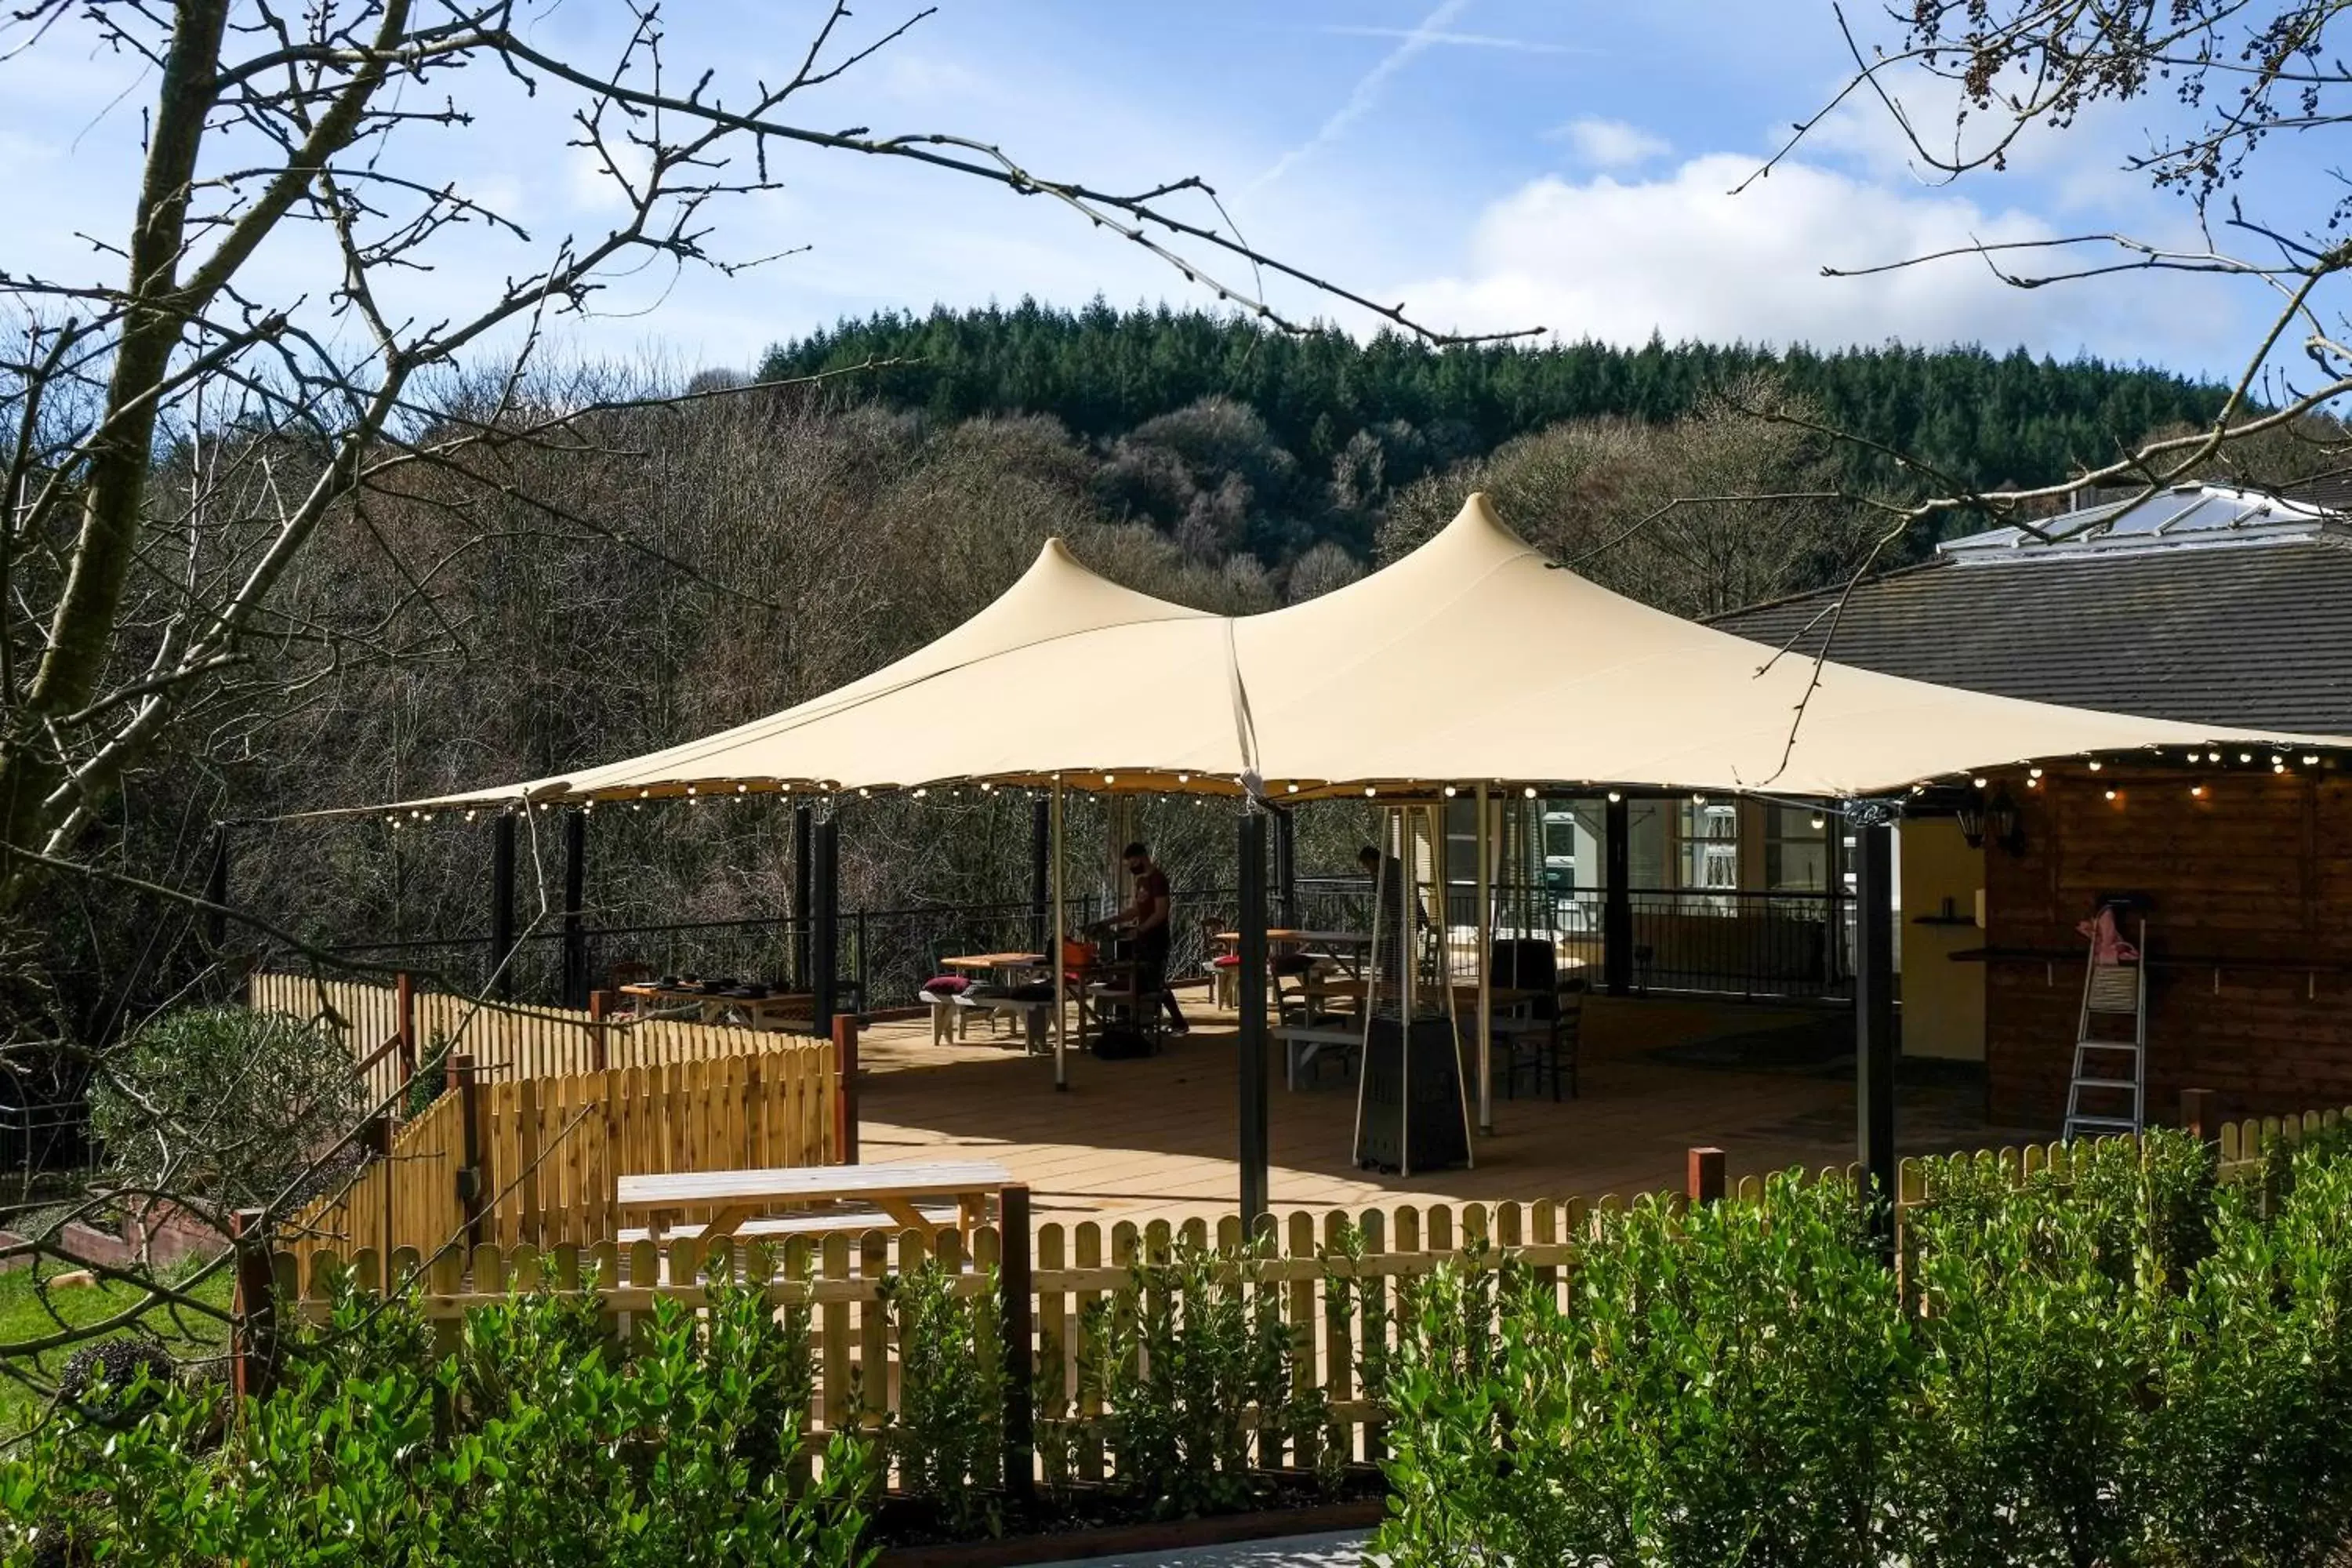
[[247, 971, 797, 1105]]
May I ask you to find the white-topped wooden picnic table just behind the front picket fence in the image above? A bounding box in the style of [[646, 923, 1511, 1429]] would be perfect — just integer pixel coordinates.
[[614, 1159, 1014, 1246]]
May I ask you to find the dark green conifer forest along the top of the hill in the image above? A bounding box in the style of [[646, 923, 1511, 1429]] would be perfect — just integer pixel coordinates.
[[760, 301, 2225, 555]]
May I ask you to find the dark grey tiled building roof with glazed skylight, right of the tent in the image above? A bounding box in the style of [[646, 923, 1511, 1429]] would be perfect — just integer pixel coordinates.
[[1715, 487, 2352, 734]]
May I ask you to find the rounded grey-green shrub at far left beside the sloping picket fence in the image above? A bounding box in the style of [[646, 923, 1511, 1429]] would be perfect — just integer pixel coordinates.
[[89, 1006, 365, 1208]]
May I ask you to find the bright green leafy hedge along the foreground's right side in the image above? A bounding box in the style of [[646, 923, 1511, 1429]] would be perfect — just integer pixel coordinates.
[[1378, 1133, 2352, 1568]]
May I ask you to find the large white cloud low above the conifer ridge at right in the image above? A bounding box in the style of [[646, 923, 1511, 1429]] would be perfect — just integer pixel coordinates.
[[1399, 153, 2239, 362]]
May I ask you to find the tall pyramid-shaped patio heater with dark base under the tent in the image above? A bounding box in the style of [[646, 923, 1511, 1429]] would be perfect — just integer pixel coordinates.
[[1355, 804, 1470, 1175]]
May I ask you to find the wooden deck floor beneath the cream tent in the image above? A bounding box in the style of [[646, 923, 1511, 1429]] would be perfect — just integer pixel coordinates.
[[858, 994, 2023, 1220]]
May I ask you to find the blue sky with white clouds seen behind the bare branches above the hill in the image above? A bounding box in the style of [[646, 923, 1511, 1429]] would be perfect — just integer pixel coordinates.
[[0, 0, 2305, 372]]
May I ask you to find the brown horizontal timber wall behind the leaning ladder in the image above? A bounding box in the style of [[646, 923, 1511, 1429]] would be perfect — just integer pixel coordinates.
[[1985, 753, 2352, 1128]]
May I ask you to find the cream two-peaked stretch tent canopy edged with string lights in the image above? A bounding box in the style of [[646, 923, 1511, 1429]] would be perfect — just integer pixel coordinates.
[[362, 496, 2352, 811]]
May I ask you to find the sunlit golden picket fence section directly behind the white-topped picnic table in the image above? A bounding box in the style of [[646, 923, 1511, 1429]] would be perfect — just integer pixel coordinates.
[[280, 1036, 842, 1262]]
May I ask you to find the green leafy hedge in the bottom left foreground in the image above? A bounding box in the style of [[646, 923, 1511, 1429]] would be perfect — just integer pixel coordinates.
[[0, 1279, 875, 1568]]
